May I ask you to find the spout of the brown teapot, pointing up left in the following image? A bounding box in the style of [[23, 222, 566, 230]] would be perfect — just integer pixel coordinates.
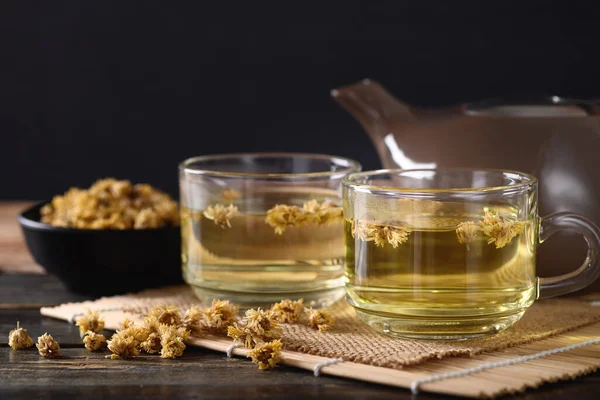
[[331, 79, 415, 137]]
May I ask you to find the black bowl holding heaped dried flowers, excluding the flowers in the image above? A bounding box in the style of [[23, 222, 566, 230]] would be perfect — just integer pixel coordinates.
[[18, 202, 183, 296]]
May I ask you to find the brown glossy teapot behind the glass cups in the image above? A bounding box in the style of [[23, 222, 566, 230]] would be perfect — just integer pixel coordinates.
[[331, 79, 600, 291]]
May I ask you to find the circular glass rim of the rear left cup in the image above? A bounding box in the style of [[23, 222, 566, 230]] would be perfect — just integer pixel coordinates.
[[179, 152, 362, 180]]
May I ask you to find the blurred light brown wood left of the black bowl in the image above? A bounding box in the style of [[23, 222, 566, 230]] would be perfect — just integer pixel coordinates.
[[0, 202, 45, 274]]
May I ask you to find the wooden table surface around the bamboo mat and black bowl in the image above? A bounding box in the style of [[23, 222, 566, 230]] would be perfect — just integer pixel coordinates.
[[0, 203, 600, 400]]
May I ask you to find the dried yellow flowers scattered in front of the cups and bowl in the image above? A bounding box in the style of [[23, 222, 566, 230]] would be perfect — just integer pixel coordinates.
[[4, 299, 333, 370]]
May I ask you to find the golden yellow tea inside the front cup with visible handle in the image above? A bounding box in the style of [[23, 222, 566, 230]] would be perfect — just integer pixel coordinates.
[[345, 209, 537, 338]]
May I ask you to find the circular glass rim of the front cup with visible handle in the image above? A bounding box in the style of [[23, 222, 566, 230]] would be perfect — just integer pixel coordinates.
[[342, 168, 538, 194]]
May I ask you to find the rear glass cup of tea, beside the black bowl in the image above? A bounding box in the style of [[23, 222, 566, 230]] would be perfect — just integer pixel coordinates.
[[179, 153, 361, 308]]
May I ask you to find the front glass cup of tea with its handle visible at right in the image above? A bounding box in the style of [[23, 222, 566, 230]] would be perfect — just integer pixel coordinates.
[[343, 169, 600, 339]]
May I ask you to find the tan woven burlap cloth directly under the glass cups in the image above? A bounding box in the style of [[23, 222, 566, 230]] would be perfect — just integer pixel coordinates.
[[42, 286, 600, 369]]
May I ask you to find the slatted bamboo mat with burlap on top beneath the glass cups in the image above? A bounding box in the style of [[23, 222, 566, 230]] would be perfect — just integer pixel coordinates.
[[41, 287, 600, 398]]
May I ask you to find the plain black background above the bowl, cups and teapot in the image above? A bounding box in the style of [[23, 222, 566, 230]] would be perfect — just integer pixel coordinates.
[[0, 0, 600, 199]]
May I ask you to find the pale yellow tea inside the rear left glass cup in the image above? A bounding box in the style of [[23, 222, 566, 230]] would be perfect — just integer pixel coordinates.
[[181, 190, 344, 306]]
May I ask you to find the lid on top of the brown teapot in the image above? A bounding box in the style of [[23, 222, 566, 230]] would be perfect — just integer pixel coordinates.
[[460, 96, 600, 117]]
